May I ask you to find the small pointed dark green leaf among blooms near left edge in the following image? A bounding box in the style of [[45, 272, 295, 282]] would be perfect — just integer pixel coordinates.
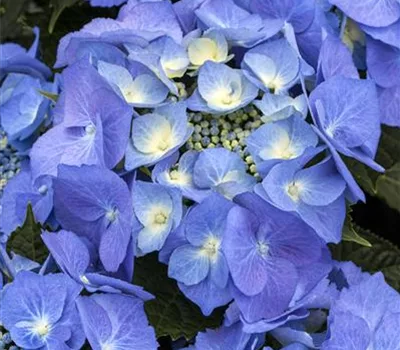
[[7, 204, 49, 263]]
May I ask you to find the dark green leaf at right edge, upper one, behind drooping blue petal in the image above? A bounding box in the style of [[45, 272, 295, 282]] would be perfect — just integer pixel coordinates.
[[345, 126, 400, 212]]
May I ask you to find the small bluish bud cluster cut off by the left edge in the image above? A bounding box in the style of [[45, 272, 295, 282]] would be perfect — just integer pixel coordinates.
[[0, 130, 21, 198]]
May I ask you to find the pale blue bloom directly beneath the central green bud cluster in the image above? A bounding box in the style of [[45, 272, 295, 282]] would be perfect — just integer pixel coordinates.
[[193, 148, 256, 199]]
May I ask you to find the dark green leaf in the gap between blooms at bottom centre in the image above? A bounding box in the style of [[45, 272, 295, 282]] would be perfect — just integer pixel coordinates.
[[134, 254, 225, 340]]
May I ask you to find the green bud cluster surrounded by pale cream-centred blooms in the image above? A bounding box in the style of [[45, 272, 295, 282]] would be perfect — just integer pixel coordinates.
[[186, 106, 263, 177]]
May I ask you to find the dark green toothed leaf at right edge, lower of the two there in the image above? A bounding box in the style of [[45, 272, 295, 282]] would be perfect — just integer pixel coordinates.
[[331, 225, 400, 291]]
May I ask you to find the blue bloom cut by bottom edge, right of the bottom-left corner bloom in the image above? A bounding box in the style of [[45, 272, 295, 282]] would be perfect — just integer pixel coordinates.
[[77, 294, 158, 350]]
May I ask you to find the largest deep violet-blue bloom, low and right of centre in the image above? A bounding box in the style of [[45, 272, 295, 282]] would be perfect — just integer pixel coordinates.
[[222, 194, 323, 322]]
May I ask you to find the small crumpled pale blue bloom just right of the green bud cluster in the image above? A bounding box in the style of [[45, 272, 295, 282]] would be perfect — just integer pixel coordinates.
[[253, 93, 308, 123]]
